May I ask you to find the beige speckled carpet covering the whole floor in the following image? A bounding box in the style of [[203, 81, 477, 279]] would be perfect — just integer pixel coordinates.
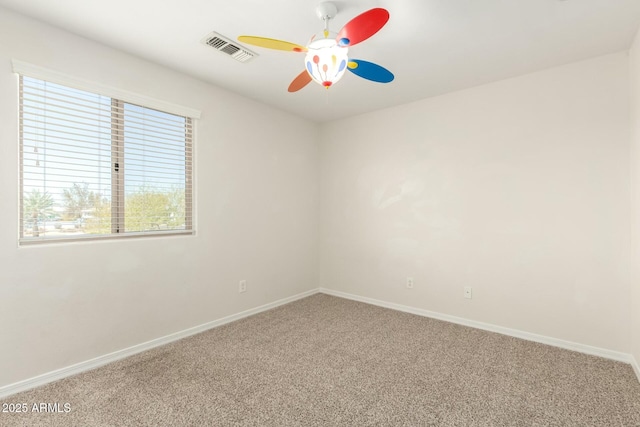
[[0, 294, 640, 427]]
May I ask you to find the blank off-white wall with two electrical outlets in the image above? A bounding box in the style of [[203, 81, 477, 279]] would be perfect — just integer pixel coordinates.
[[319, 53, 631, 353]]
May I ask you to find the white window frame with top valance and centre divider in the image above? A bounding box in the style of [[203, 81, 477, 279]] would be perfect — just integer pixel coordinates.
[[12, 60, 200, 246]]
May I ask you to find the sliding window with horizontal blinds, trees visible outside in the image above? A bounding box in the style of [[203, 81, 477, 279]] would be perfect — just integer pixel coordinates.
[[19, 74, 193, 243]]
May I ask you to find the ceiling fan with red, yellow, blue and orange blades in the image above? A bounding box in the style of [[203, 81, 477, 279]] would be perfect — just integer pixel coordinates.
[[238, 2, 394, 92]]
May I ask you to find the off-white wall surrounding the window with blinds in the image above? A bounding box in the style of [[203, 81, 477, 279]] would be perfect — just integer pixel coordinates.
[[0, 9, 318, 386]]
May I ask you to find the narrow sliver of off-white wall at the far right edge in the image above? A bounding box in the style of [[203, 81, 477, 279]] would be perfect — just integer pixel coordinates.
[[629, 32, 640, 379]]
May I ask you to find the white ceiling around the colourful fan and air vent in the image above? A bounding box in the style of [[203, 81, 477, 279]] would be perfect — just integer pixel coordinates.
[[0, 0, 640, 122]]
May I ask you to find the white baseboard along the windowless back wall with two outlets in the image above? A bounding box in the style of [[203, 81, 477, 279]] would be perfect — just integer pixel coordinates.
[[320, 288, 640, 366]]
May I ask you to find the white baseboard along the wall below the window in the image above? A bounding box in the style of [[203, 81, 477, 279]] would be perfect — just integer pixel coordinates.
[[0, 289, 319, 399]]
